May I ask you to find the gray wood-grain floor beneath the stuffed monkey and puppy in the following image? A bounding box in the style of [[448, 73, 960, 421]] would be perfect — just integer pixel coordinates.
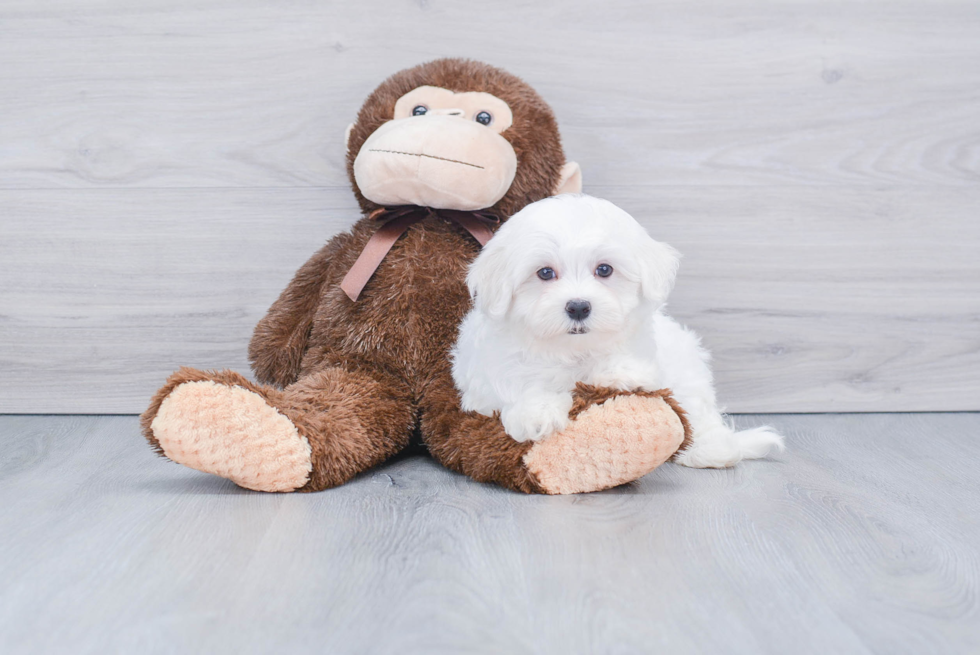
[[0, 414, 980, 654]]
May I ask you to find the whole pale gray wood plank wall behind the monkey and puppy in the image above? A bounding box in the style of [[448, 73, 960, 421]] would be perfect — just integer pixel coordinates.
[[0, 0, 980, 413]]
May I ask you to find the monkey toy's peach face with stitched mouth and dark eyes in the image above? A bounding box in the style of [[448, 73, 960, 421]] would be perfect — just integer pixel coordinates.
[[354, 86, 517, 210]]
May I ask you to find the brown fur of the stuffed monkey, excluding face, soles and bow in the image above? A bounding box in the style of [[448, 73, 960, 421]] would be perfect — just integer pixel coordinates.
[[142, 59, 683, 493]]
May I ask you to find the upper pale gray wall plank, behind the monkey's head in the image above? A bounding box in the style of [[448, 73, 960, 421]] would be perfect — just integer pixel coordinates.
[[0, 0, 980, 188]]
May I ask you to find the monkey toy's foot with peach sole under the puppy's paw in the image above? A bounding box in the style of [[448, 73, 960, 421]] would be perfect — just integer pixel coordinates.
[[524, 384, 689, 494]]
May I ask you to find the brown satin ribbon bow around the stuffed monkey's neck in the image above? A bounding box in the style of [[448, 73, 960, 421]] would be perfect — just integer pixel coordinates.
[[340, 205, 500, 300]]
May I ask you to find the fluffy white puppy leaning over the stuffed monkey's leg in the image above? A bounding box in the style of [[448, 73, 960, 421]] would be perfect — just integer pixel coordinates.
[[453, 195, 782, 467]]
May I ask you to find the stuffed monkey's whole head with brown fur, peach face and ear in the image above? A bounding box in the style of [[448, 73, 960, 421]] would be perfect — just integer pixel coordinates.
[[347, 59, 581, 218]]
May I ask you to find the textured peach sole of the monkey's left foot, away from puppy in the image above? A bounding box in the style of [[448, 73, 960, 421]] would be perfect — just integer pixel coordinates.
[[150, 380, 313, 491]]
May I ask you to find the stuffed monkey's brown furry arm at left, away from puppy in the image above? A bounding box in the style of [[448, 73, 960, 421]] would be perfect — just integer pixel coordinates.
[[248, 238, 341, 387]]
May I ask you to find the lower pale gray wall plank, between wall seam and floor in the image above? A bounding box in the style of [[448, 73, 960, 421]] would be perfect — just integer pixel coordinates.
[[0, 186, 980, 413]]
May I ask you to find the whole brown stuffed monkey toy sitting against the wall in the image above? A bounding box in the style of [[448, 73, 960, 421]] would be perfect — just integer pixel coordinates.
[[141, 59, 688, 494]]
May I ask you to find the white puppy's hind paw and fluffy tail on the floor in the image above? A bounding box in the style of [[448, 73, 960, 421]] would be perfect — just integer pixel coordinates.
[[674, 423, 785, 468]]
